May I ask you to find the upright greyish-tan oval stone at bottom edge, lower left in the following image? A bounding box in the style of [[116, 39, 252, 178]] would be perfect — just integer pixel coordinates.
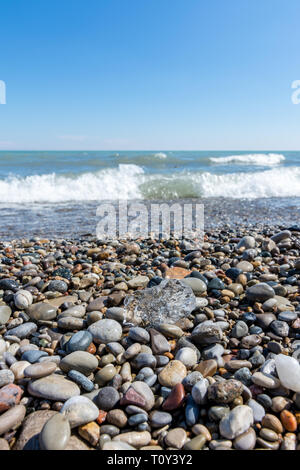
[[39, 413, 71, 450]]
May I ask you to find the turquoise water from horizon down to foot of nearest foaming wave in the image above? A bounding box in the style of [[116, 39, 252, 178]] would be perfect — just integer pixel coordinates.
[[0, 150, 300, 204]]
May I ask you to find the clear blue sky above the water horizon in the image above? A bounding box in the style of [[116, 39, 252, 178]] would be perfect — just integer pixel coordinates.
[[0, 0, 300, 150]]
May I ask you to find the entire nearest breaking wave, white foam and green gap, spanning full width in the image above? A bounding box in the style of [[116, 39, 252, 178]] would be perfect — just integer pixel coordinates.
[[0, 164, 300, 203]]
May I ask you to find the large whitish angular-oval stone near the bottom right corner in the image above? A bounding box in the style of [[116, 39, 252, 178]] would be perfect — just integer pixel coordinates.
[[219, 405, 253, 439]]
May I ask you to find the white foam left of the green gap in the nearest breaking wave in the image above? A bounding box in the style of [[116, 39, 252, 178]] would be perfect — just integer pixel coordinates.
[[0, 164, 144, 203]]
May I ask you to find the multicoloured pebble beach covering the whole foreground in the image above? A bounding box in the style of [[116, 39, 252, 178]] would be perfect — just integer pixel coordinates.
[[0, 225, 300, 452]]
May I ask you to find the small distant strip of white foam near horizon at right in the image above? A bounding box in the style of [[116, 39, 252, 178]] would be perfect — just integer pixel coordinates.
[[210, 153, 285, 166]]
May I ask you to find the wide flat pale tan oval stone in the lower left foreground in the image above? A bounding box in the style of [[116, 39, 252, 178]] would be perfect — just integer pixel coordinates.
[[28, 374, 80, 401]]
